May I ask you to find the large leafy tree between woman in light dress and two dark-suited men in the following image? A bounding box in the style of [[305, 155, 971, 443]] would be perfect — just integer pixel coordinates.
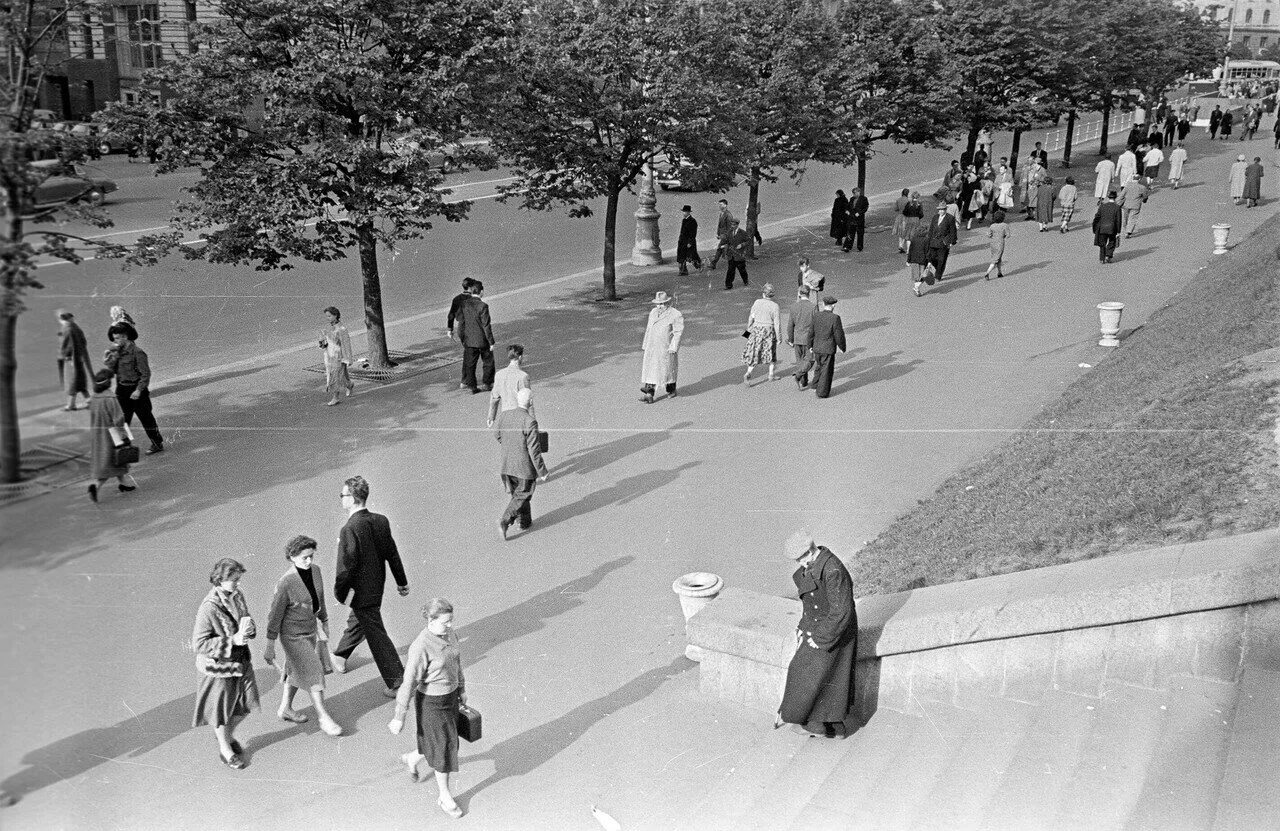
[[114, 0, 506, 367]]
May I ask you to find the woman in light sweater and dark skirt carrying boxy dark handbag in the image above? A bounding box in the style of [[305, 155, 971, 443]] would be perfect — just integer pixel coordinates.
[[387, 597, 467, 819]]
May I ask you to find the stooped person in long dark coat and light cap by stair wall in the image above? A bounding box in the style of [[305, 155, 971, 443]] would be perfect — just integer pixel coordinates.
[[773, 530, 858, 739]]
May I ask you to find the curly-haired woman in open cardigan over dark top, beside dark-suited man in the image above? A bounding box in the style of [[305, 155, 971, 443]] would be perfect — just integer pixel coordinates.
[[262, 535, 342, 736]]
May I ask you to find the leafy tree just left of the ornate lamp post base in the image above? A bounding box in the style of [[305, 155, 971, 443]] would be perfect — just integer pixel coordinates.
[[481, 0, 741, 300]]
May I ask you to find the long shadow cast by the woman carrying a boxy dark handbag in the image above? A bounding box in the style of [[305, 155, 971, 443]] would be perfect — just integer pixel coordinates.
[[456, 656, 698, 807]]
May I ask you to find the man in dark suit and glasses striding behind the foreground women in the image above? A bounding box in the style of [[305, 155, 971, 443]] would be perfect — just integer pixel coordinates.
[[333, 476, 408, 698]]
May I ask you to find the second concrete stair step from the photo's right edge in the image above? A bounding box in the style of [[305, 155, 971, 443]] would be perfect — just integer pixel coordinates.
[[1125, 677, 1239, 831]]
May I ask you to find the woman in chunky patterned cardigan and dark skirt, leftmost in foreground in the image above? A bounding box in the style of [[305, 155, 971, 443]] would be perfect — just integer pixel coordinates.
[[191, 557, 260, 771]]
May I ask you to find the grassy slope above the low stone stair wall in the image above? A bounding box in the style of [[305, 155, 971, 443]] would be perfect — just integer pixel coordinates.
[[855, 216, 1280, 592]]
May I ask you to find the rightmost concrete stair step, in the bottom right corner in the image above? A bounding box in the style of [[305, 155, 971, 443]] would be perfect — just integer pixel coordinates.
[[1212, 666, 1280, 831]]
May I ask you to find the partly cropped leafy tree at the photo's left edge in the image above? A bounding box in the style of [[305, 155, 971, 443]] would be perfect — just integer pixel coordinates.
[[0, 0, 168, 483]]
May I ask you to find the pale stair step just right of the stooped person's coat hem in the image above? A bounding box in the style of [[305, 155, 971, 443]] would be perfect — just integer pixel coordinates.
[[794, 700, 972, 831]]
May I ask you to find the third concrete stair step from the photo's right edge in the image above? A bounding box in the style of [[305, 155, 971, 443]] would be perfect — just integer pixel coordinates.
[[1044, 686, 1172, 831]]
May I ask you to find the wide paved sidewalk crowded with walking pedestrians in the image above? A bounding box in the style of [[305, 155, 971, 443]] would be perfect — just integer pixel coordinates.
[[0, 126, 1276, 830]]
